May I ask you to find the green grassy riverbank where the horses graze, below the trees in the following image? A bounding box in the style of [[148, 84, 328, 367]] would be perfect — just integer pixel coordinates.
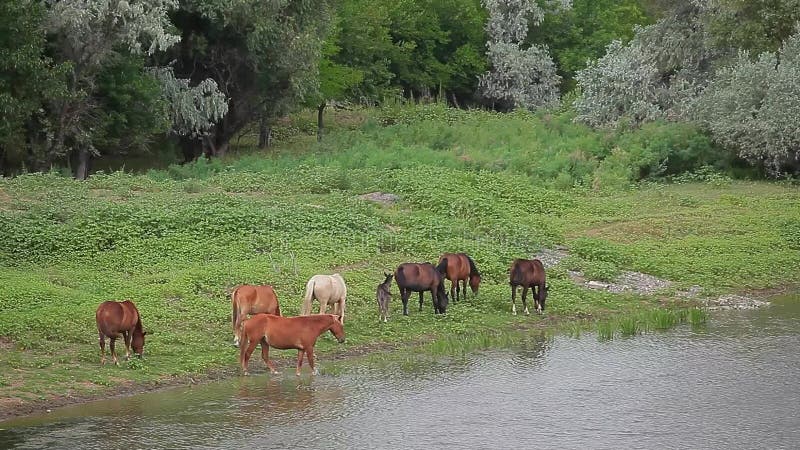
[[0, 106, 800, 418]]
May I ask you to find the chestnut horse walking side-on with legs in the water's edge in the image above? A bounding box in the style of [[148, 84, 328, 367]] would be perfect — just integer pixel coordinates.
[[239, 314, 344, 375]]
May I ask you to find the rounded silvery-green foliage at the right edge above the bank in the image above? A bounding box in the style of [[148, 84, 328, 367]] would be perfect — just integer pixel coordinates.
[[694, 28, 800, 176]]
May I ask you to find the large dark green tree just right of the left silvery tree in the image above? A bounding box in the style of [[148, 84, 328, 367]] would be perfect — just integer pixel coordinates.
[[172, 0, 332, 160]]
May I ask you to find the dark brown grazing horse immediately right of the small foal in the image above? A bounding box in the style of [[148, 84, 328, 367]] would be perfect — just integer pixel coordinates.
[[394, 258, 450, 316]]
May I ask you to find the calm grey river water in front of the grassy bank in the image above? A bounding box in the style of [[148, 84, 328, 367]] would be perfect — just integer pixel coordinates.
[[0, 297, 800, 449]]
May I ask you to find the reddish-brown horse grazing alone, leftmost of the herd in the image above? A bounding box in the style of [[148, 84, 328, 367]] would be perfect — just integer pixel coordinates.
[[94, 300, 147, 365]]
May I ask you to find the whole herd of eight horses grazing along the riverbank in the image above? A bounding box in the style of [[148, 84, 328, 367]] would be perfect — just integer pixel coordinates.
[[95, 253, 549, 375]]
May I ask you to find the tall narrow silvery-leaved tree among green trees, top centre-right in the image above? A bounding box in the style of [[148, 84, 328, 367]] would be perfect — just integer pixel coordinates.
[[479, 0, 570, 109]]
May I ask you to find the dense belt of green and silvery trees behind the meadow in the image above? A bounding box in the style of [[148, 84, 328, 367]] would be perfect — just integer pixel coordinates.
[[0, 0, 800, 179]]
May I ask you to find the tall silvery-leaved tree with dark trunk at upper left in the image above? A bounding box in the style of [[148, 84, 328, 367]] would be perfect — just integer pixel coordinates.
[[47, 0, 179, 179]]
